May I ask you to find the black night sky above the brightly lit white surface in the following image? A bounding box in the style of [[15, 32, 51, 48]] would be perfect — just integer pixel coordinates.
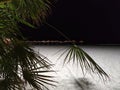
[[21, 0, 120, 44]]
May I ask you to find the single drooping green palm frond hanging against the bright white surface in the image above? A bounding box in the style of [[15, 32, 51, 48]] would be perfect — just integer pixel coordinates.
[[64, 45, 109, 80]]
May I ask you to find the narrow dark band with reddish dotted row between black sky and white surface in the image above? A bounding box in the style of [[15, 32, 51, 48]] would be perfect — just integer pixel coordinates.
[[26, 40, 120, 46]]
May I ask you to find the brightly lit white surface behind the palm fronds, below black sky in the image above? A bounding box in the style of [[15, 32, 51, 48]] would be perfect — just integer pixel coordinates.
[[30, 46, 120, 90]]
